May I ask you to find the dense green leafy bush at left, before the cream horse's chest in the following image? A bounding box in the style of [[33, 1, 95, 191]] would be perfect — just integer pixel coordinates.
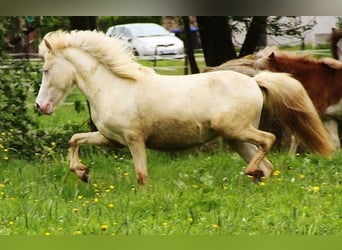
[[0, 60, 84, 161]]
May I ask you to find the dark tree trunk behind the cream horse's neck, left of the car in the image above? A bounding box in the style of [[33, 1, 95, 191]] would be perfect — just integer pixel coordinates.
[[70, 16, 97, 131]]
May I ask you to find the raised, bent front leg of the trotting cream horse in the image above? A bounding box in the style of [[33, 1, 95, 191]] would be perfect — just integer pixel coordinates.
[[69, 132, 120, 182]]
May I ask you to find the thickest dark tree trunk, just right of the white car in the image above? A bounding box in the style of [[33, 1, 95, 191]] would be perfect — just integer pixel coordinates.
[[197, 16, 236, 67]]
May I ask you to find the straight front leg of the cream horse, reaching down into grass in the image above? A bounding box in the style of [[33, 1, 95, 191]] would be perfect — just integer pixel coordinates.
[[125, 133, 148, 187]]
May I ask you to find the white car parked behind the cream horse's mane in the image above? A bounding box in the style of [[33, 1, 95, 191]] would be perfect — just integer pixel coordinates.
[[106, 23, 184, 59]]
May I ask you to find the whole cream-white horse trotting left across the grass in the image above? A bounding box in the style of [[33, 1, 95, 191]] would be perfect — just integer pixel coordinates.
[[36, 31, 333, 185]]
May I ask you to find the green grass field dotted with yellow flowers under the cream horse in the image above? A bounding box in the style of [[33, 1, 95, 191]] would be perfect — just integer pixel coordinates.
[[0, 55, 342, 236]]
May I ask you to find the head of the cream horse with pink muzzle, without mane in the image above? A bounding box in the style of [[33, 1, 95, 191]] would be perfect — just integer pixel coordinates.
[[35, 39, 74, 115]]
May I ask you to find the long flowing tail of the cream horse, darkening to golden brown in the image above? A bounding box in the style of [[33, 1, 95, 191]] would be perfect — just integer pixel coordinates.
[[254, 72, 334, 156]]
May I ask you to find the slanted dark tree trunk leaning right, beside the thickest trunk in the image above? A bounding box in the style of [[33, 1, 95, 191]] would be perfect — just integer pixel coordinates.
[[239, 16, 267, 57]]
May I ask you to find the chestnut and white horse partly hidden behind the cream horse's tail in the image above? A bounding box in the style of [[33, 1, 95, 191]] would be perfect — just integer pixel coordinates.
[[254, 47, 342, 151]]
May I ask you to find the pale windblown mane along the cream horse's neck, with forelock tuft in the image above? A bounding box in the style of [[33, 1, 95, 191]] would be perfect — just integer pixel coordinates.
[[39, 30, 153, 80]]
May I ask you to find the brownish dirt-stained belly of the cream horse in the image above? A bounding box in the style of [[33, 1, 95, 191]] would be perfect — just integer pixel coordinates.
[[146, 120, 217, 151]]
